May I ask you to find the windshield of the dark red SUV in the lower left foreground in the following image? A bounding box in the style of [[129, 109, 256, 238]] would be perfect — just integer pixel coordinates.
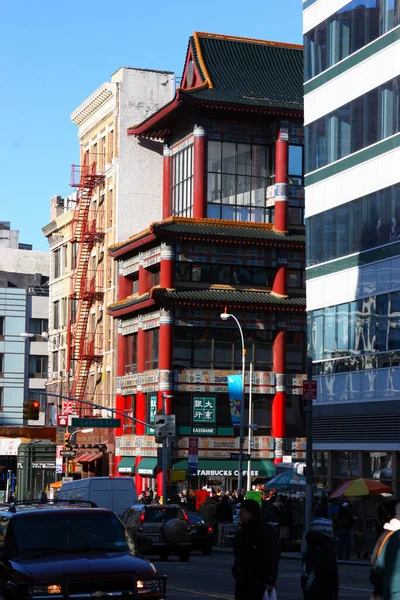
[[13, 511, 133, 555]]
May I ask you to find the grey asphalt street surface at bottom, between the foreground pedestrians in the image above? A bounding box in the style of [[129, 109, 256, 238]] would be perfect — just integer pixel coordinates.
[[154, 552, 371, 600]]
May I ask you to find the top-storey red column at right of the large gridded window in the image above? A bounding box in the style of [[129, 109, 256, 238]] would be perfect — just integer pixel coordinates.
[[274, 124, 289, 231]]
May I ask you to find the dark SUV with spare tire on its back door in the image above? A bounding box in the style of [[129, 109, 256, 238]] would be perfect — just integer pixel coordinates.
[[121, 504, 192, 562]]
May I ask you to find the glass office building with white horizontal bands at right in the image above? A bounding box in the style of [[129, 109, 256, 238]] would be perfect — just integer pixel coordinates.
[[303, 0, 400, 492]]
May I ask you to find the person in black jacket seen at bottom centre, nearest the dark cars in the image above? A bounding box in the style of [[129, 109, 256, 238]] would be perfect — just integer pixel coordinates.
[[232, 500, 280, 600]]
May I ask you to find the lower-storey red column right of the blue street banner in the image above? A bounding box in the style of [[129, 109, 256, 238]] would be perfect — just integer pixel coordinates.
[[271, 331, 286, 464]]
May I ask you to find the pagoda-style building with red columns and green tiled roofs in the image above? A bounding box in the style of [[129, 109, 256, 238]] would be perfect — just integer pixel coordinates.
[[108, 33, 306, 492]]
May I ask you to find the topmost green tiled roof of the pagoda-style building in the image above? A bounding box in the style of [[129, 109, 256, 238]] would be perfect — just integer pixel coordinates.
[[181, 33, 303, 111]]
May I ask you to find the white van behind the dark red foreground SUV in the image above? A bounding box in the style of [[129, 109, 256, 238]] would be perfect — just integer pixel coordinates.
[[57, 477, 137, 515]]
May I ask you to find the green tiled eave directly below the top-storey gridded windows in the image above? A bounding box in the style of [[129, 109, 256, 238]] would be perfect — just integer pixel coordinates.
[[153, 221, 306, 245]]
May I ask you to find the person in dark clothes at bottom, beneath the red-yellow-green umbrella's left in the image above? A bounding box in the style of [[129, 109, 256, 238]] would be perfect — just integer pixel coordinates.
[[301, 506, 339, 600]]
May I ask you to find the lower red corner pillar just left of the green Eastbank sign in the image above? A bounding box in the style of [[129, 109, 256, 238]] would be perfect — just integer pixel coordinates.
[[157, 308, 172, 494]]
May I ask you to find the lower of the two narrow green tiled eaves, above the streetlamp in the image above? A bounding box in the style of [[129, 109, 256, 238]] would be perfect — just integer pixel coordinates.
[[152, 288, 306, 310]]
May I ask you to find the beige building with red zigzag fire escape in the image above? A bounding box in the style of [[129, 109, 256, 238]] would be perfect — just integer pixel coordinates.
[[43, 68, 174, 476]]
